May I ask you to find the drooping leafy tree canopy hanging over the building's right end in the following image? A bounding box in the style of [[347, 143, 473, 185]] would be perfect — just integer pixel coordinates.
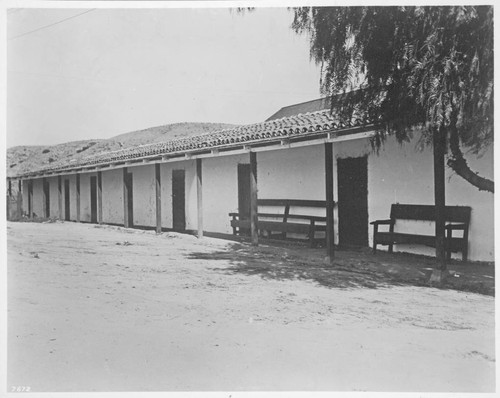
[[292, 6, 494, 192]]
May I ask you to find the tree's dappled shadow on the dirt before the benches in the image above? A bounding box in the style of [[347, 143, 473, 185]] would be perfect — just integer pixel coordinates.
[[188, 239, 495, 296]]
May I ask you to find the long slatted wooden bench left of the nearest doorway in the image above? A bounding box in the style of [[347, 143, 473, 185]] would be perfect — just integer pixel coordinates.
[[229, 199, 326, 247]]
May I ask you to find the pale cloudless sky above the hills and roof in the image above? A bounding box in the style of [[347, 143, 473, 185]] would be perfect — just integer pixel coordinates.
[[6, 8, 320, 148]]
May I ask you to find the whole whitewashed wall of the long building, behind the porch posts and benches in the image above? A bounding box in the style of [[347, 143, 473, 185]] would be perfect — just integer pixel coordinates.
[[19, 130, 494, 261]]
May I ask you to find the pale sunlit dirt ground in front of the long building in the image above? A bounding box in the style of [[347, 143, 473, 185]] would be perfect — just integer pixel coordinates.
[[7, 222, 495, 392]]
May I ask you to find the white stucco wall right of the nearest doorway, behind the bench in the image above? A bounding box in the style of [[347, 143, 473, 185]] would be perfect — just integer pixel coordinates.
[[365, 135, 494, 261]]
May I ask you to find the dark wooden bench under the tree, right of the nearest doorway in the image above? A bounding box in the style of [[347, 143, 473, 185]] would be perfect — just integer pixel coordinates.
[[370, 204, 471, 261]]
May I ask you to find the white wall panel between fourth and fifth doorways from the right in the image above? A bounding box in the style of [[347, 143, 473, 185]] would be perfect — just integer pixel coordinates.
[[102, 169, 124, 225]]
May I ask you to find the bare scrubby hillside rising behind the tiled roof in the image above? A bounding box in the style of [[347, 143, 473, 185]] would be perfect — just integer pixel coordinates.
[[7, 123, 233, 177]]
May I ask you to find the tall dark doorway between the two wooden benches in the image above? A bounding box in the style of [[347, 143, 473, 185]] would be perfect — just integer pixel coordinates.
[[337, 156, 368, 246]]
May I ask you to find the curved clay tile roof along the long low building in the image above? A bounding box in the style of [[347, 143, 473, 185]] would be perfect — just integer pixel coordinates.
[[20, 109, 378, 176]]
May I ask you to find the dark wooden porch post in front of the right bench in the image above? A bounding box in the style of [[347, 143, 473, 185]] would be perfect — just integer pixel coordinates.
[[433, 129, 446, 271]]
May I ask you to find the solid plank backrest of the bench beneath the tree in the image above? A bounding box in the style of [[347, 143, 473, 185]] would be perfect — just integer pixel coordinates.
[[391, 204, 471, 224]]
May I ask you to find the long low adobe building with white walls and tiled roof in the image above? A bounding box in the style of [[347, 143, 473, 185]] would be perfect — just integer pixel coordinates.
[[5, 100, 494, 261]]
